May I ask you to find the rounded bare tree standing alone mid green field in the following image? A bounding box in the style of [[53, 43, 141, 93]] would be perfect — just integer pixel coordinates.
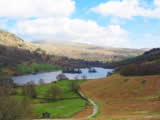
[[46, 85, 64, 101]]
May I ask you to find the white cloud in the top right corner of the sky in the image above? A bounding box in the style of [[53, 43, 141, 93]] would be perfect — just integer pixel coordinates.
[[92, 0, 160, 19]]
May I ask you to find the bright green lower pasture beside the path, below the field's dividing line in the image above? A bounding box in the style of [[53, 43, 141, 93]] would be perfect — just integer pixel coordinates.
[[35, 98, 87, 118]]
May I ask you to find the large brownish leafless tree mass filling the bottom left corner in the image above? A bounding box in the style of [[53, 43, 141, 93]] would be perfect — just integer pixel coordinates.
[[0, 86, 32, 120]]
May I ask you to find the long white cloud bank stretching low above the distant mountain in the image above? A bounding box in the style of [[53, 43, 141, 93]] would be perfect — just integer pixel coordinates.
[[13, 17, 129, 47]]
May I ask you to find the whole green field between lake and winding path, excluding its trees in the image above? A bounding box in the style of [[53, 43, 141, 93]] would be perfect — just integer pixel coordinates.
[[17, 80, 88, 118]]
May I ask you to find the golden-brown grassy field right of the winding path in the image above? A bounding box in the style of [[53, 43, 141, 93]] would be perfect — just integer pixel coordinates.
[[81, 75, 160, 120]]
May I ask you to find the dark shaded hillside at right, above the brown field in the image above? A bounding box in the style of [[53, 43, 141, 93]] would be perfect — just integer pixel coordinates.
[[110, 48, 160, 75]]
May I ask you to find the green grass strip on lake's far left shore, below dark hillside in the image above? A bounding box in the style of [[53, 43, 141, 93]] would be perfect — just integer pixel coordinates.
[[16, 64, 61, 74]]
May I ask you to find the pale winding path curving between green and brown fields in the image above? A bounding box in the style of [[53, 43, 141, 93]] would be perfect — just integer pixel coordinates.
[[79, 92, 98, 118]]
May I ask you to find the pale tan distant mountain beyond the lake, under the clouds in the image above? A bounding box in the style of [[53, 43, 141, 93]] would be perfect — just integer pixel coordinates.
[[33, 40, 146, 62]]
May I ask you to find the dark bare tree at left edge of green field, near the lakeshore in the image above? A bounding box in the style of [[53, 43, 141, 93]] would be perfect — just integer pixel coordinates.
[[22, 82, 37, 98]]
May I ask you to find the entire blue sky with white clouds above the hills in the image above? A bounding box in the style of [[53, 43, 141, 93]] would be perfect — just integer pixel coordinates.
[[0, 0, 160, 48]]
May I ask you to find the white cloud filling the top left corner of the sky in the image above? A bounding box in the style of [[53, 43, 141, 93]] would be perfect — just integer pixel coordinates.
[[0, 0, 75, 18]]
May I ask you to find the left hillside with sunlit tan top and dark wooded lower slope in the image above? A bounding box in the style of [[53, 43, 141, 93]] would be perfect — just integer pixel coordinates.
[[0, 30, 102, 74]]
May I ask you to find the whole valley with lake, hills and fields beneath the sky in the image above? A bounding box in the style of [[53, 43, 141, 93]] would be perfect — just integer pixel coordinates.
[[0, 31, 160, 120]]
